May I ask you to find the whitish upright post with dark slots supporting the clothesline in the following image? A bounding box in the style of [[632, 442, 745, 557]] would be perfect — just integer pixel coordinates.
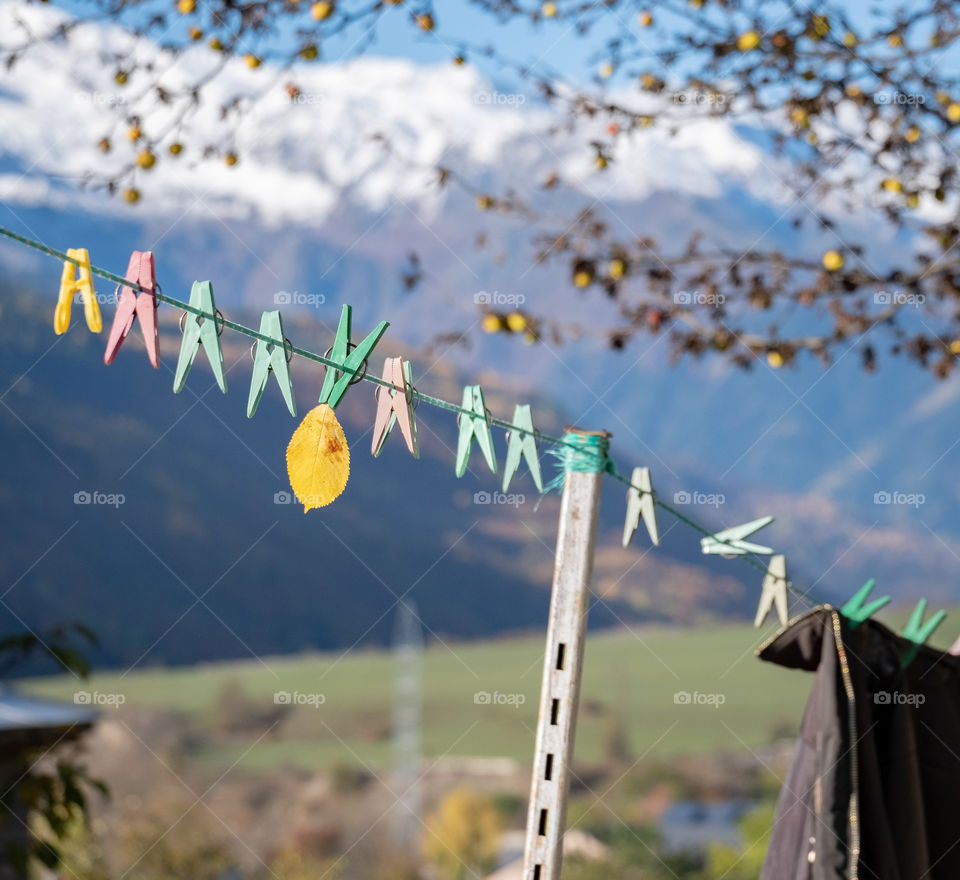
[[523, 428, 609, 880]]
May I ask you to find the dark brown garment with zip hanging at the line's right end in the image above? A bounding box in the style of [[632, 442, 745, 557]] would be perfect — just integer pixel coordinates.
[[757, 605, 960, 880]]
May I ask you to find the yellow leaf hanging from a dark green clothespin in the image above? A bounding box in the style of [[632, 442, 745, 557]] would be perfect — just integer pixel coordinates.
[[287, 403, 350, 513]]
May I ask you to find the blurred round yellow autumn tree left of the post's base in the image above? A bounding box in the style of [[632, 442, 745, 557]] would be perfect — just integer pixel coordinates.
[[423, 788, 500, 880]]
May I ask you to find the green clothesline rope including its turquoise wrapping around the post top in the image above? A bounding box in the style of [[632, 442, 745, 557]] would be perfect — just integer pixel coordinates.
[[0, 226, 816, 604]]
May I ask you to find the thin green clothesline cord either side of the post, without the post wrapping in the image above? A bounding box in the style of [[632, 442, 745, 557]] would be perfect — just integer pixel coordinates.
[[0, 226, 816, 604]]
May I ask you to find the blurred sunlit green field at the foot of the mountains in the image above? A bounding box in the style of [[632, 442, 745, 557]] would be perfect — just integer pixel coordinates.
[[23, 624, 824, 769]]
